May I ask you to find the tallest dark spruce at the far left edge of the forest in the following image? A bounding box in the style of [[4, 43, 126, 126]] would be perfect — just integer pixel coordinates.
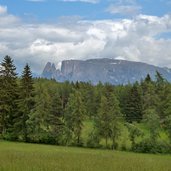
[[0, 56, 18, 139]]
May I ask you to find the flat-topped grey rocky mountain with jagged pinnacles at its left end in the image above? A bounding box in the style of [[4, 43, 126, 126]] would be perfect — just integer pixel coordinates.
[[42, 58, 171, 85]]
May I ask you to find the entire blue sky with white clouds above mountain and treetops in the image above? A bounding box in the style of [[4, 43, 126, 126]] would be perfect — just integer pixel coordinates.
[[0, 0, 171, 73]]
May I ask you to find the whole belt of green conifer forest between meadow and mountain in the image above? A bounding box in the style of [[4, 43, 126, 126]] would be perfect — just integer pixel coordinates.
[[0, 56, 171, 153]]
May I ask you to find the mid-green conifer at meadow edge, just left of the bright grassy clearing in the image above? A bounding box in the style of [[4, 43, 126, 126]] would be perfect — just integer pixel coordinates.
[[64, 91, 85, 145]]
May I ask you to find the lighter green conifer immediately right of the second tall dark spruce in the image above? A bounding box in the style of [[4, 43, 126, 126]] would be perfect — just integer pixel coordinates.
[[27, 80, 52, 143]]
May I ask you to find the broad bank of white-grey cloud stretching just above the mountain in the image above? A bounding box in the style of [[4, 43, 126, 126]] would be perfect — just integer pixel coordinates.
[[0, 5, 171, 73]]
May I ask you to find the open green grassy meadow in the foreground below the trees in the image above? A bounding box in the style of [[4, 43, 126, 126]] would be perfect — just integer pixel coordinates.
[[0, 141, 171, 171]]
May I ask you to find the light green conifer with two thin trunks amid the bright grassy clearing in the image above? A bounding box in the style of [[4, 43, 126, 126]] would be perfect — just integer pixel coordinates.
[[95, 92, 122, 149]]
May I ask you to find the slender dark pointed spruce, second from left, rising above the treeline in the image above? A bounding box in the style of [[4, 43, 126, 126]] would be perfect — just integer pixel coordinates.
[[15, 64, 34, 142]]
